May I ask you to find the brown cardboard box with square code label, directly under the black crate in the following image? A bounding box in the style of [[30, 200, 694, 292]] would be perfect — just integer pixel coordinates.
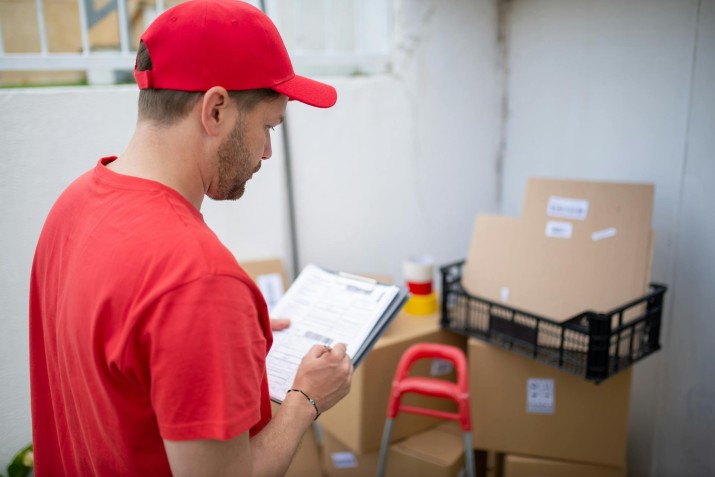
[[468, 338, 631, 467]]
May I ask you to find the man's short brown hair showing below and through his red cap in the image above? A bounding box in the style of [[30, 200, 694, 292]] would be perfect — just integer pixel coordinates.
[[136, 42, 281, 126]]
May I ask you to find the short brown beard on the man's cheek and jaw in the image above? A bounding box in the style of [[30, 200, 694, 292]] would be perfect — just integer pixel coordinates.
[[209, 118, 261, 200]]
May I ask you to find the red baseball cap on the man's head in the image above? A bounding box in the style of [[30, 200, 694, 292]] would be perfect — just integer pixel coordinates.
[[134, 0, 337, 108]]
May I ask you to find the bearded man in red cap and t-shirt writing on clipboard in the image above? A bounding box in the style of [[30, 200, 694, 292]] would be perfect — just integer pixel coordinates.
[[30, 0, 352, 477]]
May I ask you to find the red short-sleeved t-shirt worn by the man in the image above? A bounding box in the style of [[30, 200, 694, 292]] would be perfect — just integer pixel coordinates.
[[30, 158, 272, 477]]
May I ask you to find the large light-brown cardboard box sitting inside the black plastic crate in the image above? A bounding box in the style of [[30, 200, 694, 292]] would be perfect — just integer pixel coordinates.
[[463, 179, 653, 321]]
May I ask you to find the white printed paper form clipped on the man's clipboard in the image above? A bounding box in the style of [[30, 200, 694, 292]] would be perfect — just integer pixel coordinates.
[[266, 265, 399, 401]]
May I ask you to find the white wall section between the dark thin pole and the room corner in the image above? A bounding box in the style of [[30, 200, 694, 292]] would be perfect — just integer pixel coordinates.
[[289, 0, 499, 281]]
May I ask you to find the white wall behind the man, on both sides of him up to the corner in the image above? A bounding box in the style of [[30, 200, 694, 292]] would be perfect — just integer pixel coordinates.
[[0, 0, 499, 466]]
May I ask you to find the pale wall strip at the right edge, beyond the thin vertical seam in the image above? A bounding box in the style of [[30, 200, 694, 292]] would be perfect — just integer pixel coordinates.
[[653, 0, 715, 476]]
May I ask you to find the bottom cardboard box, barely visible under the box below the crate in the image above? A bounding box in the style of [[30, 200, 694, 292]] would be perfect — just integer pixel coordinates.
[[502, 454, 626, 477]]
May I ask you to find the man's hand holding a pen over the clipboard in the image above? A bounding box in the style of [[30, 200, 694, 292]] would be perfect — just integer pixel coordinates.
[[293, 343, 353, 413]]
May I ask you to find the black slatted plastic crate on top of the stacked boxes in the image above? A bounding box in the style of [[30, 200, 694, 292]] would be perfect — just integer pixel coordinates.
[[441, 261, 667, 383]]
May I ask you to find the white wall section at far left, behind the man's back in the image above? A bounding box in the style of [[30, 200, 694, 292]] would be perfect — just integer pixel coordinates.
[[0, 89, 135, 462]]
